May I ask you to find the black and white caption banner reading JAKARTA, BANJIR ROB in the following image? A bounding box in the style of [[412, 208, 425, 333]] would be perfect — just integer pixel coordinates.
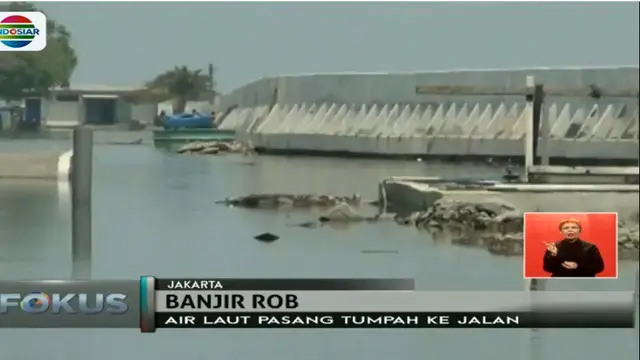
[[141, 279, 633, 332]]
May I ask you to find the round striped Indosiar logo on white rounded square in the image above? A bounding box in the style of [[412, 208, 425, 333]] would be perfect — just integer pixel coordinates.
[[0, 11, 47, 51]]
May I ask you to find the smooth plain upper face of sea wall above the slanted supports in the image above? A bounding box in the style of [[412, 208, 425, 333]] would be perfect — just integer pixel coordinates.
[[220, 66, 639, 109]]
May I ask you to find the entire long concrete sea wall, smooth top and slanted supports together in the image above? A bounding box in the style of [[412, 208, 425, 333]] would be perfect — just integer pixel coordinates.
[[220, 67, 638, 161]]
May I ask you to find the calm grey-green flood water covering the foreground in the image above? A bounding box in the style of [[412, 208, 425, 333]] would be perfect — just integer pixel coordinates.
[[0, 134, 638, 360]]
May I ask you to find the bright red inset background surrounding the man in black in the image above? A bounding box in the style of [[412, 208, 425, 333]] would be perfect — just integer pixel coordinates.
[[523, 213, 618, 278]]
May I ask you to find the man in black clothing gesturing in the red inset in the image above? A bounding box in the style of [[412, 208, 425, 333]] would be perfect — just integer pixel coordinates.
[[543, 219, 604, 277]]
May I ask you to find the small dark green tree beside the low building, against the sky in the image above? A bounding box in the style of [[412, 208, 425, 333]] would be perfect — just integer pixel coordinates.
[[147, 66, 214, 113]]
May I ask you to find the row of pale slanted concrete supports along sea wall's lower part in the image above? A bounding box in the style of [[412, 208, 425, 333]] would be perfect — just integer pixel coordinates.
[[220, 103, 638, 161]]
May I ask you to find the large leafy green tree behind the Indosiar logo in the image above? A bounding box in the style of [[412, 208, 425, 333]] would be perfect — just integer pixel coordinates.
[[0, 2, 78, 99]]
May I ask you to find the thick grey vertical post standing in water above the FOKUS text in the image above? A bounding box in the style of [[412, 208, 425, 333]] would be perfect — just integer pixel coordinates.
[[71, 126, 93, 279]]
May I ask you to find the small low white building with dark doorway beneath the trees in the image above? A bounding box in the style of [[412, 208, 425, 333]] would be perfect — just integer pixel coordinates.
[[24, 86, 158, 127]]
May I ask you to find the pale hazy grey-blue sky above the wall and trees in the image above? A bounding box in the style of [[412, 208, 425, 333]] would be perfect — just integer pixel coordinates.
[[37, 2, 640, 92]]
